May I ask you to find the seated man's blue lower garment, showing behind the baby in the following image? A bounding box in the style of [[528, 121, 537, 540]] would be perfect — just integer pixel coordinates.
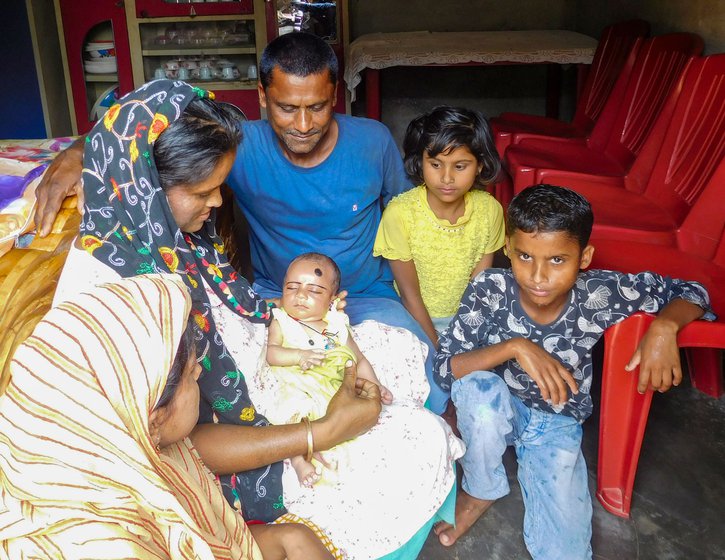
[[252, 283, 450, 414]]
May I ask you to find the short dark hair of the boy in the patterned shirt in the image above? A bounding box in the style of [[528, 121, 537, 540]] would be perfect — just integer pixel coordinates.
[[506, 184, 594, 249]]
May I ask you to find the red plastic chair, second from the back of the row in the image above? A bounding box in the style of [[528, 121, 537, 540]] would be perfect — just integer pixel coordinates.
[[499, 33, 703, 203]]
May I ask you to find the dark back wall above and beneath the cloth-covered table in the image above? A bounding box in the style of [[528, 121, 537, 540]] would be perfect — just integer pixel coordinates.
[[349, 0, 576, 144]]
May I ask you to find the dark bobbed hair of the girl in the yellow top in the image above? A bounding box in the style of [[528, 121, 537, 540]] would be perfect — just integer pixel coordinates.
[[403, 105, 501, 188]]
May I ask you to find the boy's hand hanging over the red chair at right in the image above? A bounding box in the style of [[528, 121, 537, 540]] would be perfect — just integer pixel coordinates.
[[624, 318, 682, 393]]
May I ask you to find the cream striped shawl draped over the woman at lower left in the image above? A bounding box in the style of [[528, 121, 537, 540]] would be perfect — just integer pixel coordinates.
[[0, 275, 261, 560]]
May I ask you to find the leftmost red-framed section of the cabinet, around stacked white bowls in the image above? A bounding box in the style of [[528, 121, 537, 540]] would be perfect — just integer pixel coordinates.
[[55, 0, 134, 134]]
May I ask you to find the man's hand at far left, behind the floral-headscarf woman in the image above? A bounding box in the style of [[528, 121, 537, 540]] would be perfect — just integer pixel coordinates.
[[35, 137, 85, 237]]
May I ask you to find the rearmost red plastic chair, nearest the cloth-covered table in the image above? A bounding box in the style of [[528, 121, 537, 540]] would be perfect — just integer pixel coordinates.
[[489, 19, 649, 158]]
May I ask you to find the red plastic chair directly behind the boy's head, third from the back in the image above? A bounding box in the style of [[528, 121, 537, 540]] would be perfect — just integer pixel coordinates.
[[516, 54, 725, 246]]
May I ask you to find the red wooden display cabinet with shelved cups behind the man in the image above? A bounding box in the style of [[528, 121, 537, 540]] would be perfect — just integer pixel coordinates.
[[55, 0, 348, 134]]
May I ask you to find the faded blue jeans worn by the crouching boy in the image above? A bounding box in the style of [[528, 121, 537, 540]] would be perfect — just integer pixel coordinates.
[[451, 371, 592, 560]]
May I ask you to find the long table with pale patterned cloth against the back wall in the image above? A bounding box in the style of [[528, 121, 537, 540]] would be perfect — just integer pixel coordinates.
[[344, 29, 597, 120]]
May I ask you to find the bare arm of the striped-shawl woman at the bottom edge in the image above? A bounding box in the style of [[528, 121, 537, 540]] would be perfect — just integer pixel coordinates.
[[249, 523, 332, 560]]
